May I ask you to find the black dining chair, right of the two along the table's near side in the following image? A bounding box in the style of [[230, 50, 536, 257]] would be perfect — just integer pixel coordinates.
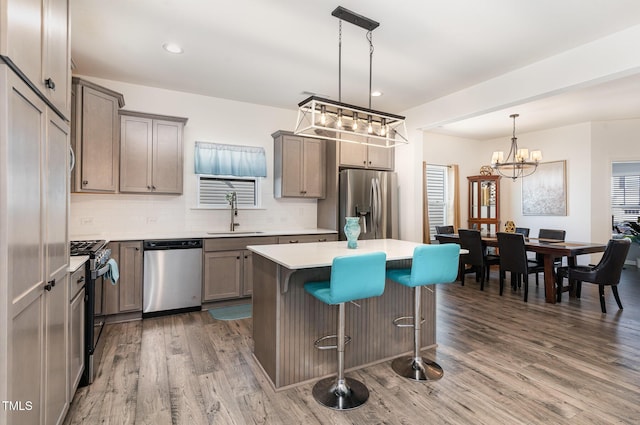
[[496, 232, 529, 302]]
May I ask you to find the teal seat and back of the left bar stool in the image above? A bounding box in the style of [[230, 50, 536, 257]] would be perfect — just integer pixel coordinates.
[[304, 252, 387, 304]]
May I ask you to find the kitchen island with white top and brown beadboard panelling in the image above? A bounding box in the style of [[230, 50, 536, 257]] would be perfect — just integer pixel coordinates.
[[247, 239, 435, 390]]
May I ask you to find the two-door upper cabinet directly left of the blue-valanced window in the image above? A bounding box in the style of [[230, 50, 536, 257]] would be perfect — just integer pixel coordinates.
[[120, 111, 187, 194]]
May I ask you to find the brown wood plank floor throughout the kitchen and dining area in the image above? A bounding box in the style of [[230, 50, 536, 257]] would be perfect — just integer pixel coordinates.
[[65, 267, 640, 425]]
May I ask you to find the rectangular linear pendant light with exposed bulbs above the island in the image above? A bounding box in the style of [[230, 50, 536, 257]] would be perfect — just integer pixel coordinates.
[[294, 6, 409, 148]]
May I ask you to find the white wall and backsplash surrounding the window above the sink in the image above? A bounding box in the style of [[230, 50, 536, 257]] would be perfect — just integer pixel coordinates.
[[69, 77, 316, 239]]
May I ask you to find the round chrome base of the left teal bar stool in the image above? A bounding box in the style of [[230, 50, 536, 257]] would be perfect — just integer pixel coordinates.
[[312, 377, 369, 410]]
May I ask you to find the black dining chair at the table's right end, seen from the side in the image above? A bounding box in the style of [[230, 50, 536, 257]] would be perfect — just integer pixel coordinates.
[[556, 239, 631, 313]]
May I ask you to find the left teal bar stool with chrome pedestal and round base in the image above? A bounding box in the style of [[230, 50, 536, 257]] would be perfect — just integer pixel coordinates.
[[304, 252, 387, 410]]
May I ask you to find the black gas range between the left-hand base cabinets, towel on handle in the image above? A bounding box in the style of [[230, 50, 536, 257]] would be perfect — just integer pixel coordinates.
[[70, 240, 111, 385]]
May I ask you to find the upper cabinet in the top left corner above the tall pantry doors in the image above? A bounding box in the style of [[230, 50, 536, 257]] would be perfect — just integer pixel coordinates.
[[0, 0, 71, 119]]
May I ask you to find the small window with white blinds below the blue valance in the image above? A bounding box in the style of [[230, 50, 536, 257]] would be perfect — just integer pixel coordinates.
[[198, 175, 260, 208]]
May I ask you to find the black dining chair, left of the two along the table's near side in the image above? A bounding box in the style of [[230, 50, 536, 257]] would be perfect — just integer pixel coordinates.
[[458, 229, 500, 291]]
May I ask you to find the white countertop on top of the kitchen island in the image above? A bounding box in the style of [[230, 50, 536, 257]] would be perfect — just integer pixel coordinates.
[[247, 239, 421, 270]]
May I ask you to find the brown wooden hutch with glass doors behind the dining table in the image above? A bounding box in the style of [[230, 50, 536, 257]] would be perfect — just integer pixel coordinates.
[[467, 176, 501, 235]]
